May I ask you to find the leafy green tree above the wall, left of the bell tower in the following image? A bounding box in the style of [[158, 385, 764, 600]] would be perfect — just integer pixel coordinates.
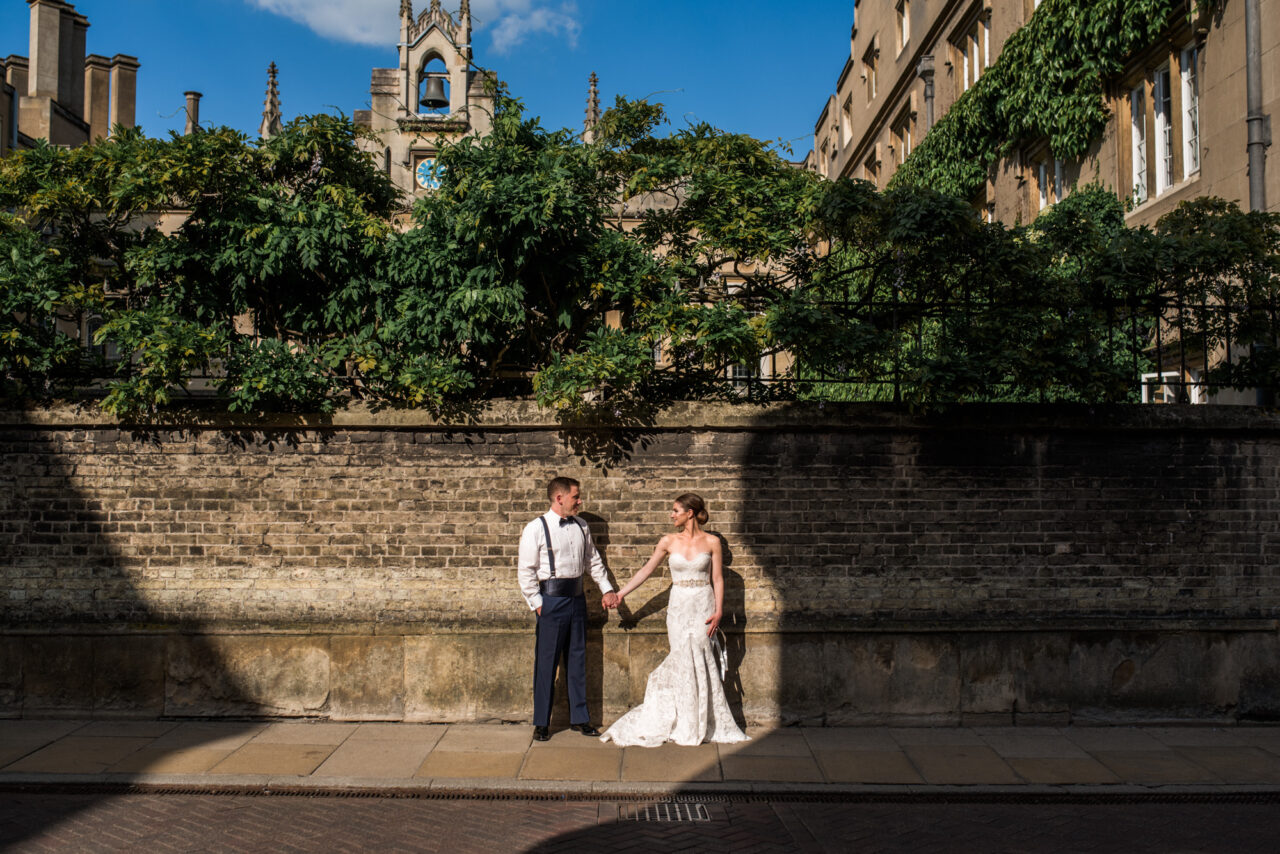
[[0, 115, 396, 414]]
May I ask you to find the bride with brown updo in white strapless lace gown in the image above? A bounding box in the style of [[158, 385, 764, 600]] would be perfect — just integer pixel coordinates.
[[600, 493, 748, 748]]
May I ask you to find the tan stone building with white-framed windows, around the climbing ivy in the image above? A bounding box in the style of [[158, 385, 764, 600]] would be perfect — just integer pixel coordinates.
[[809, 0, 1280, 225]]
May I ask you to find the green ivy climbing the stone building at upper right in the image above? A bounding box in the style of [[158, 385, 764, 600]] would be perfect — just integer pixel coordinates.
[[890, 0, 1219, 198]]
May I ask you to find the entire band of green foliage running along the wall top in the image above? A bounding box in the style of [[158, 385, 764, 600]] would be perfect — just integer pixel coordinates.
[[0, 84, 1280, 421]]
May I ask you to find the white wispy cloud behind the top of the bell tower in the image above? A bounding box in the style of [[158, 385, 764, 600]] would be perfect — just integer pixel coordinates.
[[247, 0, 580, 54]]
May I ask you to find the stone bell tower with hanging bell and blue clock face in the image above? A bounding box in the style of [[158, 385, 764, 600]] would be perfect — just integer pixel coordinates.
[[355, 0, 495, 198]]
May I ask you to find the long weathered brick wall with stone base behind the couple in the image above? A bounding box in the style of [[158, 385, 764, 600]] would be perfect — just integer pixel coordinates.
[[0, 403, 1280, 722]]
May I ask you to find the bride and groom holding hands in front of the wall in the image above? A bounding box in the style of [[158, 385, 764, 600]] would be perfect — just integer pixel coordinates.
[[518, 478, 748, 748]]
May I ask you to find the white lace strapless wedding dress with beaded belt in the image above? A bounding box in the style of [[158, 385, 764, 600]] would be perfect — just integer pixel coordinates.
[[600, 552, 748, 748]]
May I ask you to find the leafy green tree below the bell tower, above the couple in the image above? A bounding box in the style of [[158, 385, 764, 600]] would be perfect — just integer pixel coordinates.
[[388, 95, 820, 415]]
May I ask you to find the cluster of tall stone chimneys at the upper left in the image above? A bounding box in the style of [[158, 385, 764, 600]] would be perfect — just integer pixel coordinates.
[[0, 0, 138, 156]]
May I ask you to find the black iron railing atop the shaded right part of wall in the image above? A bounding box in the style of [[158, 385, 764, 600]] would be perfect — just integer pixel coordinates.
[[723, 296, 1280, 403]]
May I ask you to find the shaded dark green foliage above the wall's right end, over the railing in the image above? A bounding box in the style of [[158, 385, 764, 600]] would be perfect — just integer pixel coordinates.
[[788, 181, 1280, 406]]
